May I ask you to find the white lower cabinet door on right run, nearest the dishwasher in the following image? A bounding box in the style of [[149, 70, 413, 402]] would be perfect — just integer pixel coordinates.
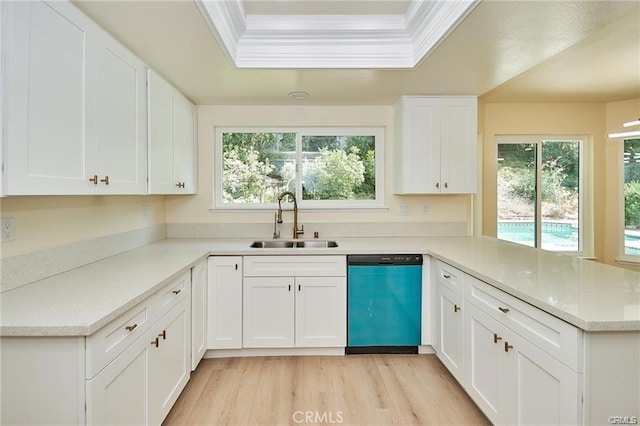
[[436, 284, 464, 383]]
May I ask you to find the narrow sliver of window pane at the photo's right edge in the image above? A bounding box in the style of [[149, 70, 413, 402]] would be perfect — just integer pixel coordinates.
[[624, 139, 640, 256]]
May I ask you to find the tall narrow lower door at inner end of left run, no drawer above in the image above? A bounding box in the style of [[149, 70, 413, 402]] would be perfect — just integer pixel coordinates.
[[191, 260, 209, 371]]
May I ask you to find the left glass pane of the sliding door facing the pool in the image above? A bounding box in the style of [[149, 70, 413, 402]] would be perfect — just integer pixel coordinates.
[[498, 143, 536, 247]]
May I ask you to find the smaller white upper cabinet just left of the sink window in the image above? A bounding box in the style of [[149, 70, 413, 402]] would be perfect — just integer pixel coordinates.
[[148, 70, 196, 194]]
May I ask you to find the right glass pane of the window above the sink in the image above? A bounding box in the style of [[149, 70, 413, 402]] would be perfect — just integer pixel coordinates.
[[302, 136, 376, 200]]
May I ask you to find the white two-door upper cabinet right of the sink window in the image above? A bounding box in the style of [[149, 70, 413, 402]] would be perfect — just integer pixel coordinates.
[[394, 96, 478, 194]]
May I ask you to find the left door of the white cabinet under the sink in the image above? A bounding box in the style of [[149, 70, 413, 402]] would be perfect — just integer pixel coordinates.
[[242, 277, 295, 348]]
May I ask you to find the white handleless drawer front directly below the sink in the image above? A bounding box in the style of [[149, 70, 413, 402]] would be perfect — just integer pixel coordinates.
[[243, 256, 347, 277]]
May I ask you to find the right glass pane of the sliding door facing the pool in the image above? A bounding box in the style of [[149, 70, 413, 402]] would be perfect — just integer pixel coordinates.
[[540, 141, 580, 251]]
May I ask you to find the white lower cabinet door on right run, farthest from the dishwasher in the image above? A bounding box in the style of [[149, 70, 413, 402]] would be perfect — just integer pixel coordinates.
[[505, 332, 582, 425]]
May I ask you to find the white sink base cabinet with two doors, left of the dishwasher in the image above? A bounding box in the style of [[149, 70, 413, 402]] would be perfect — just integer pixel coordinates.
[[242, 256, 347, 348]]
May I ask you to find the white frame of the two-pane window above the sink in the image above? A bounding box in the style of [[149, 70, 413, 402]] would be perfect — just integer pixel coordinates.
[[211, 127, 385, 211]]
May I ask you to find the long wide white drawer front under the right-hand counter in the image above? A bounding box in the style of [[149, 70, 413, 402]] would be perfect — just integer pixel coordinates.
[[465, 275, 582, 372]]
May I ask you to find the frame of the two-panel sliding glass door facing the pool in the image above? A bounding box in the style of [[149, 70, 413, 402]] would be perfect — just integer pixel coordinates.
[[495, 135, 593, 257]]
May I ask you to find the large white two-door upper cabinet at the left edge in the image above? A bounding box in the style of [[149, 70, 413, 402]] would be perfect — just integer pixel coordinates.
[[2, 1, 146, 195]]
